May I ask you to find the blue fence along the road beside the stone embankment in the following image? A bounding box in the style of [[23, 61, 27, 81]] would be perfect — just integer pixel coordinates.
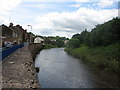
[[2, 44, 24, 59]]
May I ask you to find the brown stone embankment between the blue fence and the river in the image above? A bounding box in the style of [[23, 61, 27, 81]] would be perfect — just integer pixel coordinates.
[[2, 44, 42, 88]]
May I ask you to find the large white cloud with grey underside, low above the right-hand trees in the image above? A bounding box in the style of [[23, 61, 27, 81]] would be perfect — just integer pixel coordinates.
[[36, 8, 118, 37]]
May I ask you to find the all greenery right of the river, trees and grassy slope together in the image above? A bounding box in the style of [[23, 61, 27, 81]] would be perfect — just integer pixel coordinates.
[[65, 18, 120, 74]]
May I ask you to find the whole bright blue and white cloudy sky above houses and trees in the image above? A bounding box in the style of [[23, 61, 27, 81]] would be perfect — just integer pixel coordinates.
[[0, 0, 119, 38]]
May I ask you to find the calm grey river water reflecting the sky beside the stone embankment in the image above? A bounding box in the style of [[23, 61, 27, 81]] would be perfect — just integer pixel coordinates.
[[35, 48, 119, 88]]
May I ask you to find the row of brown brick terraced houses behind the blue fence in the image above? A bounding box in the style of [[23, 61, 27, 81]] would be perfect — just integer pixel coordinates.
[[0, 23, 34, 47]]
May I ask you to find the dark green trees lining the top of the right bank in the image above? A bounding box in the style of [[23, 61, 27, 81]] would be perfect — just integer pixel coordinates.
[[67, 17, 120, 48]]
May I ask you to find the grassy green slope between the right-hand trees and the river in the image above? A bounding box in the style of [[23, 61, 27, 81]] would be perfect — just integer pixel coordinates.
[[65, 44, 120, 74]]
